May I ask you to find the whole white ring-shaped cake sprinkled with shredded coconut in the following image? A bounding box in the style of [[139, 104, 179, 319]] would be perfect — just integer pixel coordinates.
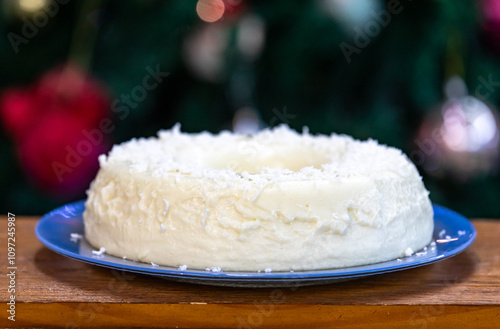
[[84, 125, 434, 271]]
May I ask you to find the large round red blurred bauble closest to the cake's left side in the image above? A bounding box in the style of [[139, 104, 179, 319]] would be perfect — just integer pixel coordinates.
[[18, 114, 109, 199]]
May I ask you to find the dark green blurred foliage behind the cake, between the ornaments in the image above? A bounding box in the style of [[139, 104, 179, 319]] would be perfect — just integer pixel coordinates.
[[0, 0, 500, 218]]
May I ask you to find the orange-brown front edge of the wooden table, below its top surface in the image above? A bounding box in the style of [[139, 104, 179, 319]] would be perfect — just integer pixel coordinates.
[[0, 303, 500, 328]]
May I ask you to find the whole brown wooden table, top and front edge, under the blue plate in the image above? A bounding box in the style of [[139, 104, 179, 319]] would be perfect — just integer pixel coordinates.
[[0, 216, 500, 328]]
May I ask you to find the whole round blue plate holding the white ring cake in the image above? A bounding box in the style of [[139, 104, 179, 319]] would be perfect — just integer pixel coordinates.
[[35, 201, 476, 287]]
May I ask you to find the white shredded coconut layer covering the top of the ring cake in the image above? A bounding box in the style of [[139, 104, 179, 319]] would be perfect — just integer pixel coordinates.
[[99, 125, 415, 183]]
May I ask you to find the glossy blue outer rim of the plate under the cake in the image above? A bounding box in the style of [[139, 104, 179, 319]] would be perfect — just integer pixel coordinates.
[[35, 200, 477, 283]]
